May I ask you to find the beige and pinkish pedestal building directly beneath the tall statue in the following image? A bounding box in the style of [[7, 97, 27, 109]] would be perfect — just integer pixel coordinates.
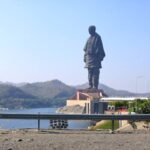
[[67, 89, 108, 114]]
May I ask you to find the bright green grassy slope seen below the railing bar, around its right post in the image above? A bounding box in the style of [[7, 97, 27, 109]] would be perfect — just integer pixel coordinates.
[[91, 120, 119, 130]]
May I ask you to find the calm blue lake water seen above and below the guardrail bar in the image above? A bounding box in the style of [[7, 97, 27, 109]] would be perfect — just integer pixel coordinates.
[[0, 108, 90, 129]]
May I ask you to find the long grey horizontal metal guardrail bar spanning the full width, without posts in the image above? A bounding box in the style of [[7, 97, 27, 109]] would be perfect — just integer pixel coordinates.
[[0, 114, 150, 120]]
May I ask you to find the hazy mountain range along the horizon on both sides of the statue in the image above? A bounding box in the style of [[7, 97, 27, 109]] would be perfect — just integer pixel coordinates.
[[0, 80, 150, 108]]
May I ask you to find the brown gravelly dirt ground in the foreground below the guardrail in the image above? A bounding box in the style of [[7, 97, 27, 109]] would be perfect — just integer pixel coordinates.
[[0, 129, 150, 150]]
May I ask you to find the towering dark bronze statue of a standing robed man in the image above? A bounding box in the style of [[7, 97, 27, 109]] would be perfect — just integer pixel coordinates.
[[84, 26, 105, 89]]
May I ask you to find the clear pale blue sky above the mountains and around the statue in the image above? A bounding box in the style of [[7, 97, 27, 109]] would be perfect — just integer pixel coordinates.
[[0, 0, 150, 92]]
